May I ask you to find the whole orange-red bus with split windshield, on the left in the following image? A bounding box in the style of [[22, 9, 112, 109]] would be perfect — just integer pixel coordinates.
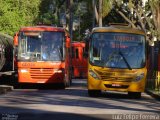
[[14, 26, 71, 87]]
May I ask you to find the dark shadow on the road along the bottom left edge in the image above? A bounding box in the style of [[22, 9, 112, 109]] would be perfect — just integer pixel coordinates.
[[0, 107, 112, 120]]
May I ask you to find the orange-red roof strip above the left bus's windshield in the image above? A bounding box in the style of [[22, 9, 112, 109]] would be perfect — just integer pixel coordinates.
[[20, 25, 65, 32]]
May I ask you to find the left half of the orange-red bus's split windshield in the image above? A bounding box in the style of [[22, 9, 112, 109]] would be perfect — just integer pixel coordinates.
[[18, 32, 41, 61]]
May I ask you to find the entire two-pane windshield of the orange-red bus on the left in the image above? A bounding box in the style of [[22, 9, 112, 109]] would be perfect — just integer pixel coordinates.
[[18, 31, 65, 61]]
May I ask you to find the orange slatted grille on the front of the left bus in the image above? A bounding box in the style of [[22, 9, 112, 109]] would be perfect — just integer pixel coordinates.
[[30, 68, 54, 79]]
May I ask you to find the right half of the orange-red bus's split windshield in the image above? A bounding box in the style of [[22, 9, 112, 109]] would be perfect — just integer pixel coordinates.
[[41, 32, 65, 61]]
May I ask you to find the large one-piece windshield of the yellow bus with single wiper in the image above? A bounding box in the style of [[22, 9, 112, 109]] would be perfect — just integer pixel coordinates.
[[89, 33, 146, 70]]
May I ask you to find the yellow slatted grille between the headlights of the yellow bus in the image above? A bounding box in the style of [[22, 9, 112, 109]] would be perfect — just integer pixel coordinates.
[[95, 70, 134, 82]]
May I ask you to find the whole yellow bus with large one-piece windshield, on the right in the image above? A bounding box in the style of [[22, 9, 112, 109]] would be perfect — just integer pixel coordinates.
[[87, 25, 147, 98]]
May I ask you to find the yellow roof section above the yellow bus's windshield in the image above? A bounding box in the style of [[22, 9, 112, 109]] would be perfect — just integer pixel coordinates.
[[92, 25, 145, 35]]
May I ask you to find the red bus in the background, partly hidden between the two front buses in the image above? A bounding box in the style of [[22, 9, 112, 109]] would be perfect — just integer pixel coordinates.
[[71, 41, 87, 78]]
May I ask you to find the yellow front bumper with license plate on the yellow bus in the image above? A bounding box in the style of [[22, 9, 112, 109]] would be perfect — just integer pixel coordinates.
[[88, 77, 145, 92]]
